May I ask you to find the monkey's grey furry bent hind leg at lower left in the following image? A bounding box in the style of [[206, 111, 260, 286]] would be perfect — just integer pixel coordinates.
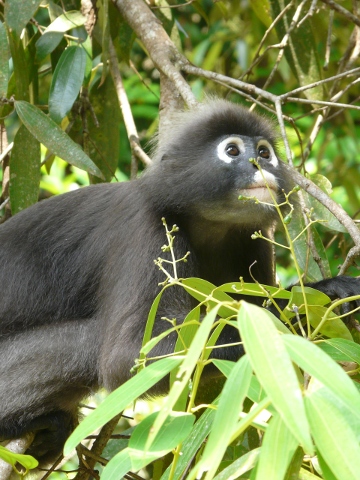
[[0, 319, 100, 462]]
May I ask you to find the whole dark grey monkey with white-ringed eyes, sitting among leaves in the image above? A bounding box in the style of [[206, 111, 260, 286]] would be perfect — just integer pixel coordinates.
[[0, 99, 360, 462]]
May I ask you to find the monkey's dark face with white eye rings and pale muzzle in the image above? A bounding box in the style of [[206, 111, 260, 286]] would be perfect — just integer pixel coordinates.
[[186, 135, 288, 224]]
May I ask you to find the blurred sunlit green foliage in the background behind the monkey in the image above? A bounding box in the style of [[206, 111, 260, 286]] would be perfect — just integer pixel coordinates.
[[0, 0, 360, 480]]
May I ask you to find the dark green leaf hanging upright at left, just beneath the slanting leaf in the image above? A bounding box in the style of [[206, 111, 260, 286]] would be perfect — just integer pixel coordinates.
[[9, 125, 41, 215]]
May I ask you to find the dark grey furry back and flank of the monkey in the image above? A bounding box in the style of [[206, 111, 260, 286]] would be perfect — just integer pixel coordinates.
[[0, 181, 156, 334]]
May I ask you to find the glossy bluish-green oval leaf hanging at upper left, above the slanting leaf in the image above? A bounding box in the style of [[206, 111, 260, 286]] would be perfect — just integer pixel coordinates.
[[49, 46, 86, 123]]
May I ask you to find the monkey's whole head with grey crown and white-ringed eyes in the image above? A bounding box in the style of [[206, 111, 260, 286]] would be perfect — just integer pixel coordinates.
[[145, 100, 292, 226]]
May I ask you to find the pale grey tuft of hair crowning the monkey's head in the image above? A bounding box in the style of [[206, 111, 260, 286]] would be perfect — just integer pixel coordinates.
[[152, 99, 278, 162]]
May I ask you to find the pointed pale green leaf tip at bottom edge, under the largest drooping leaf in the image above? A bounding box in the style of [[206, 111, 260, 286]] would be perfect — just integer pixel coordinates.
[[256, 414, 299, 480]]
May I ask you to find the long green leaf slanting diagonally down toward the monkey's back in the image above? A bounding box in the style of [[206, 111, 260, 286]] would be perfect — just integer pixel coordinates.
[[15, 101, 102, 178]]
